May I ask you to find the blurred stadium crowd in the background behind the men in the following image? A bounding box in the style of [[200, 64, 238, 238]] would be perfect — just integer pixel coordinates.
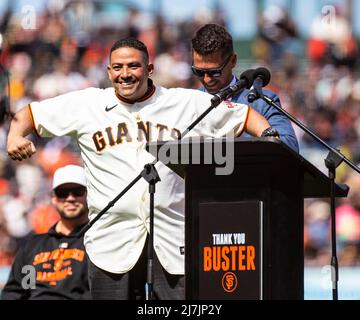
[[0, 0, 360, 292]]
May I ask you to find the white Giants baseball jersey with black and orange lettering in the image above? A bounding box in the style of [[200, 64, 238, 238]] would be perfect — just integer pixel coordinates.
[[30, 87, 248, 274]]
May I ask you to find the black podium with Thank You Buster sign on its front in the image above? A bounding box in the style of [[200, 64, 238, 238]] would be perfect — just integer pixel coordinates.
[[148, 138, 348, 300]]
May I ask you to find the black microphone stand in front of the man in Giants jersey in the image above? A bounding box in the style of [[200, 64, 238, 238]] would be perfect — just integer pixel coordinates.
[[77, 91, 226, 300]]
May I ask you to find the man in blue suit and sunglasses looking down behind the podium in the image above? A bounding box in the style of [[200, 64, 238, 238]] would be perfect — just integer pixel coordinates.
[[191, 24, 299, 152]]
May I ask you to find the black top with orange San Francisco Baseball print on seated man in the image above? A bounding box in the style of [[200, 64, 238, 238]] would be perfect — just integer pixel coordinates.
[[1, 225, 90, 300]]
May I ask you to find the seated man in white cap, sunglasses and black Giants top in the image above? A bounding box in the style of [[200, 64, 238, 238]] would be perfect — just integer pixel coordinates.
[[1, 165, 91, 300]]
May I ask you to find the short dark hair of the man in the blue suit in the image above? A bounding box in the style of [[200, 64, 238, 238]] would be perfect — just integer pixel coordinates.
[[191, 23, 234, 57]]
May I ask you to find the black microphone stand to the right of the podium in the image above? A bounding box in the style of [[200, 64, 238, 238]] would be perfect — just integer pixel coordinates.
[[258, 94, 360, 300]]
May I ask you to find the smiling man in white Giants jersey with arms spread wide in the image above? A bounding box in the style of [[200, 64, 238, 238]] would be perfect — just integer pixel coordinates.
[[7, 38, 270, 299]]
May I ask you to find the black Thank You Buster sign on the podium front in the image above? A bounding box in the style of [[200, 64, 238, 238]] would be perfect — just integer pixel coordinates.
[[198, 201, 263, 300]]
